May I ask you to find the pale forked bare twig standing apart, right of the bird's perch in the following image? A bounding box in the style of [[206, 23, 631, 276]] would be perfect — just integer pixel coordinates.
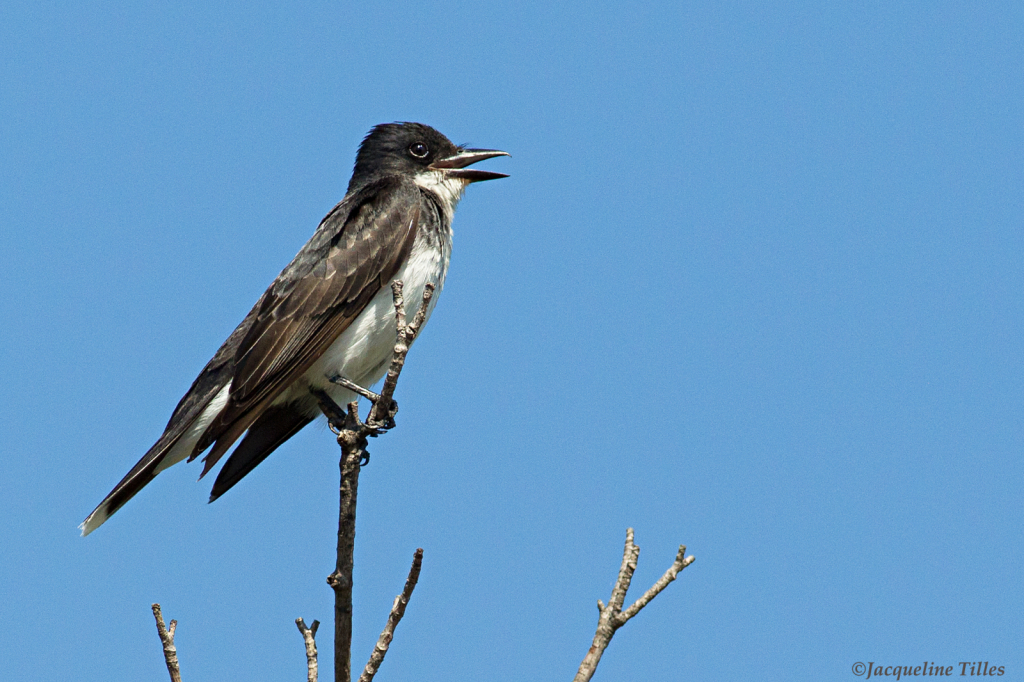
[[572, 528, 693, 682]]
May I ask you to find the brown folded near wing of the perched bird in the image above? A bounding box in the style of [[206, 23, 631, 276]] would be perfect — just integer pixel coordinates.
[[191, 178, 421, 474]]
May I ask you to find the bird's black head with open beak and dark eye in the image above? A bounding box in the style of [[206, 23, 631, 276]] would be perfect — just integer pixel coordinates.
[[348, 123, 508, 191]]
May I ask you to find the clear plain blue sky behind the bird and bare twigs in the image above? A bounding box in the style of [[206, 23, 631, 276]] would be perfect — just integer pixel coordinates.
[[0, 2, 1024, 680]]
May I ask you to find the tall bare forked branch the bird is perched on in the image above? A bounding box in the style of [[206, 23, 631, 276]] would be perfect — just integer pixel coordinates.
[[305, 281, 434, 682]]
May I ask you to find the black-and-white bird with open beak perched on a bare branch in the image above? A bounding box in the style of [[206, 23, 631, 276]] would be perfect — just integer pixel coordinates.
[[79, 122, 509, 536]]
